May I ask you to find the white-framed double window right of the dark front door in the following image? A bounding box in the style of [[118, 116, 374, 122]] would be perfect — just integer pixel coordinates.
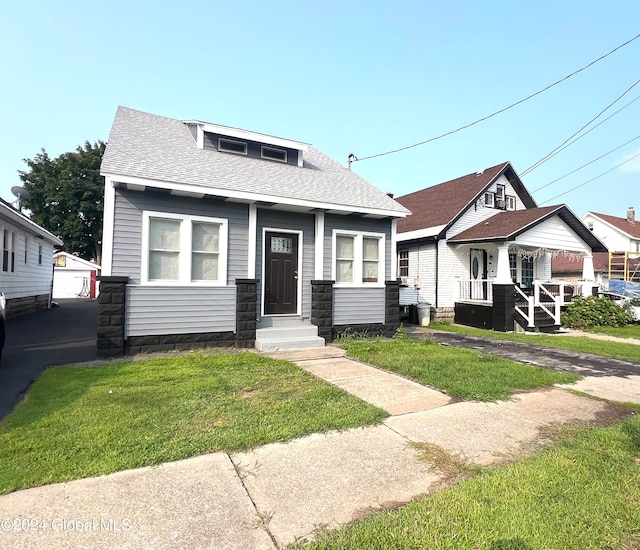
[[333, 230, 384, 286]]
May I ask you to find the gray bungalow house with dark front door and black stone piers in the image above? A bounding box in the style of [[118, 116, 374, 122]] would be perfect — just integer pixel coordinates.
[[98, 107, 409, 356]]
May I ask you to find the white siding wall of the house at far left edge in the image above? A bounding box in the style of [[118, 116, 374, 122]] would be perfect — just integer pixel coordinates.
[[0, 219, 53, 300]]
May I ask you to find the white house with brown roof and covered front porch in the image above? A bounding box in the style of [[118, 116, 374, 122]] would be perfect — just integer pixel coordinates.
[[397, 162, 607, 330]]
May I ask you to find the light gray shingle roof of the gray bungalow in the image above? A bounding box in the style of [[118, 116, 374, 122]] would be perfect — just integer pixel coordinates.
[[101, 107, 408, 216]]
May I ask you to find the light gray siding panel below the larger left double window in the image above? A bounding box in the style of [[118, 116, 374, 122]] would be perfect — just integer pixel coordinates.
[[125, 285, 236, 338]]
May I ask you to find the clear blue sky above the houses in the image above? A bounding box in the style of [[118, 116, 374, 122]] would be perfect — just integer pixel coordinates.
[[0, 0, 640, 220]]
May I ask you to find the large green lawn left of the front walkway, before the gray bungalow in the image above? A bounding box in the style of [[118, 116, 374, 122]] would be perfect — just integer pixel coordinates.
[[0, 352, 387, 494]]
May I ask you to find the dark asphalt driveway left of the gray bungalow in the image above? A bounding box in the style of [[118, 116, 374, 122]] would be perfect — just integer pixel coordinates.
[[0, 300, 98, 419]]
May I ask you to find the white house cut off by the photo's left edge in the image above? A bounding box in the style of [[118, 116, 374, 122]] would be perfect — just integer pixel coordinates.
[[0, 199, 62, 317]]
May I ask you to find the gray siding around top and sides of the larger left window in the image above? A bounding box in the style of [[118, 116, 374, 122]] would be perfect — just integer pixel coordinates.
[[111, 190, 249, 285]]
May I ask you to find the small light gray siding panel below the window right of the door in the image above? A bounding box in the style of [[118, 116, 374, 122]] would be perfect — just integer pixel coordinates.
[[333, 287, 385, 325]]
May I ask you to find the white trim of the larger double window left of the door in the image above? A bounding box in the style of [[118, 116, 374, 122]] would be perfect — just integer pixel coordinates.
[[140, 210, 229, 287]]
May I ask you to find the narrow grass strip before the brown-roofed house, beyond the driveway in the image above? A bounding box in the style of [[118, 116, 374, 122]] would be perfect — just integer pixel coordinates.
[[429, 323, 640, 362]]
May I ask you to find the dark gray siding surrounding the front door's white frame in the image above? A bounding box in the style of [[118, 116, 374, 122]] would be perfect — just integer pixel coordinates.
[[256, 209, 315, 318]]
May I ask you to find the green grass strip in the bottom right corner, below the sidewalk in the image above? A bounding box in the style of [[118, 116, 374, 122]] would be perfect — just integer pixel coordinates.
[[296, 416, 640, 550]]
